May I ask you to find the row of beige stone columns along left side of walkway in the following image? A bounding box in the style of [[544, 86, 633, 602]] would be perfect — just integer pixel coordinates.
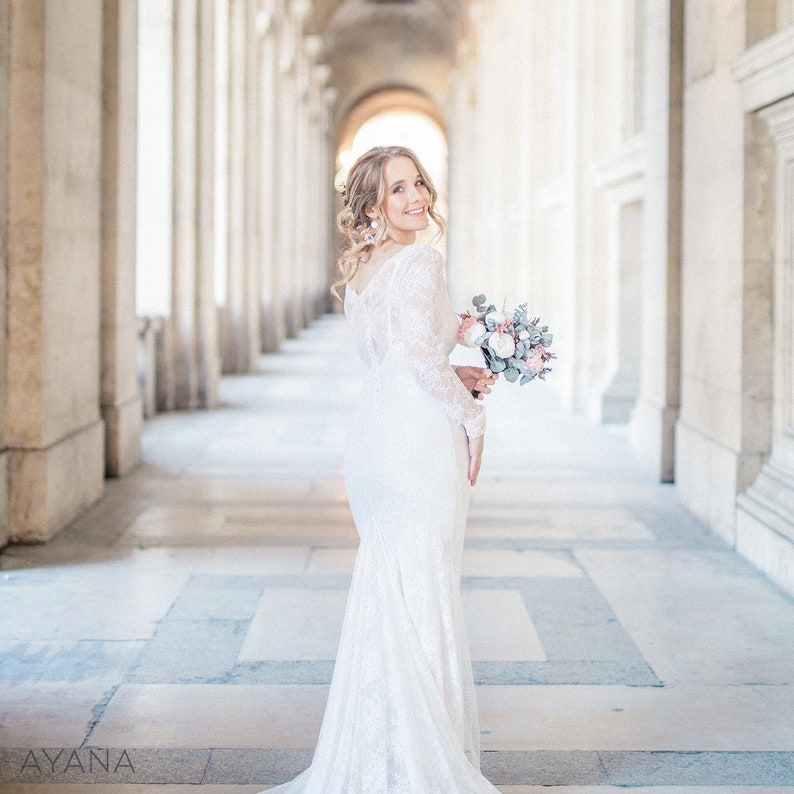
[[0, 0, 333, 544]]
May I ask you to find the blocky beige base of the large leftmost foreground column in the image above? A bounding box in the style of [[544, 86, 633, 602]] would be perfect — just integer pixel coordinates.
[[8, 420, 105, 543]]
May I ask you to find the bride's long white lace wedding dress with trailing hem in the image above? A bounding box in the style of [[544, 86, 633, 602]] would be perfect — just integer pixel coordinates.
[[266, 245, 496, 794]]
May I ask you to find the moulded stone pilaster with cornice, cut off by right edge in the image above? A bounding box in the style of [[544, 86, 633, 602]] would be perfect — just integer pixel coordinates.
[[733, 27, 794, 595]]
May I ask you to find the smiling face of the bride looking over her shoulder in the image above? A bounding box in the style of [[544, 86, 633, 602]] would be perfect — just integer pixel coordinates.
[[367, 157, 430, 245]]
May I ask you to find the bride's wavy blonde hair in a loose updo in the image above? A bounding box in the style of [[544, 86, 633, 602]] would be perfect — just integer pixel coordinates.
[[331, 146, 445, 298]]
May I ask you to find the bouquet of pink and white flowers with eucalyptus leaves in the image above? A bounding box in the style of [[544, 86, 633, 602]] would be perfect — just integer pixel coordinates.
[[458, 295, 556, 386]]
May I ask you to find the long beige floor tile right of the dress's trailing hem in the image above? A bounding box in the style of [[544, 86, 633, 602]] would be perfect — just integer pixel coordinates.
[[477, 686, 794, 751]]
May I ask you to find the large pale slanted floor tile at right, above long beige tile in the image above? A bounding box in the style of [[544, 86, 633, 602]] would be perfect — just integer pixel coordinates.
[[577, 549, 794, 688]]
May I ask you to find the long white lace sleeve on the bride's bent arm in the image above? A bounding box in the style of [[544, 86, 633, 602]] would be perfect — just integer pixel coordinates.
[[398, 247, 485, 438]]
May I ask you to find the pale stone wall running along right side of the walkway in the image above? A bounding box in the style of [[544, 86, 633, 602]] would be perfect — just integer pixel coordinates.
[[449, 0, 794, 592]]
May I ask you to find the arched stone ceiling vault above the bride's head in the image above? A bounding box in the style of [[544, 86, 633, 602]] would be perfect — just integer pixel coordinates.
[[305, 0, 470, 131]]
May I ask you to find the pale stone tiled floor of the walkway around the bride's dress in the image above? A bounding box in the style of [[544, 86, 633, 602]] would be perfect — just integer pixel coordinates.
[[0, 317, 794, 794]]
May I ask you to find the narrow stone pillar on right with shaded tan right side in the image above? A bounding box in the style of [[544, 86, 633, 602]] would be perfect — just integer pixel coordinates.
[[631, 0, 683, 482]]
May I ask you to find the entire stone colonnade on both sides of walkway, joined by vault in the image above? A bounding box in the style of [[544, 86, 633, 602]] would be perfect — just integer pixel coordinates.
[[0, 0, 794, 592]]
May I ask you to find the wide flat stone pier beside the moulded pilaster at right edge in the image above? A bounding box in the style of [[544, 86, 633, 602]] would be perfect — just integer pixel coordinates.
[[675, 3, 772, 544]]
